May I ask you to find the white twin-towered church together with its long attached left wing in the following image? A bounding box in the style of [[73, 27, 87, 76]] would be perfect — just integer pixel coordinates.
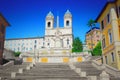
[[5, 10, 73, 52]]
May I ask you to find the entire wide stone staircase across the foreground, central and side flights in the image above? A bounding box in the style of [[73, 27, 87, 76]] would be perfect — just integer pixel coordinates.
[[0, 61, 120, 80]]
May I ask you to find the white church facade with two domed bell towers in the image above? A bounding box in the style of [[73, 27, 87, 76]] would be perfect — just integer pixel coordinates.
[[45, 10, 73, 49]]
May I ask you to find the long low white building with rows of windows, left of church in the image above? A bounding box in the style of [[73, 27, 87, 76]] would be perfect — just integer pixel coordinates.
[[5, 37, 44, 52]]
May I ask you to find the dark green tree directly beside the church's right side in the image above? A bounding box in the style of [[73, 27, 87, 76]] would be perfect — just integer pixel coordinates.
[[72, 37, 83, 52]]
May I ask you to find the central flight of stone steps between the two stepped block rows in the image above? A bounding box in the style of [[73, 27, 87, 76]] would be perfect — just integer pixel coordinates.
[[12, 63, 88, 80]]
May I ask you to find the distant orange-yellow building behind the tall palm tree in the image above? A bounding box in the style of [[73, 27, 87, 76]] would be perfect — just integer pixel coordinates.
[[85, 27, 100, 50]]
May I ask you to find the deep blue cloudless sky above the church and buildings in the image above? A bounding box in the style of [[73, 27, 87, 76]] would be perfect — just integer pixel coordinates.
[[0, 0, 107, 42]]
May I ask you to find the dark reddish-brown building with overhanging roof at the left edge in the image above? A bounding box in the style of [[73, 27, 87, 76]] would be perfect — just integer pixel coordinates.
[[0, 13, 10, 64]]
